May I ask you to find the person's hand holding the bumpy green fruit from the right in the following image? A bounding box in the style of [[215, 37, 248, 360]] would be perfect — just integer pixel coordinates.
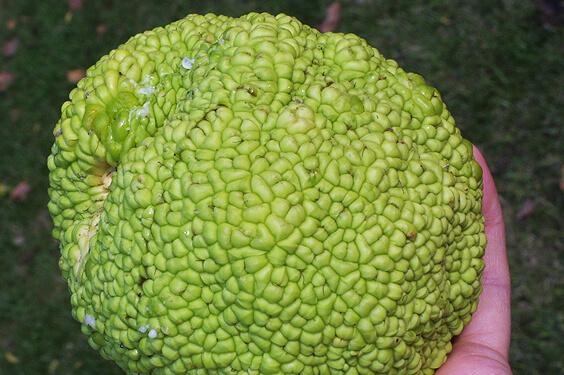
[[437, 148, 511, 375]]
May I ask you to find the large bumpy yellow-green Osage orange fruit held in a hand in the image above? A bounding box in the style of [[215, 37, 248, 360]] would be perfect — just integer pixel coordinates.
[[48, 13, 486, 375]]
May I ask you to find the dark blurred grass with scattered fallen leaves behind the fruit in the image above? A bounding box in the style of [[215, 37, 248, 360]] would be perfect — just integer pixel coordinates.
[[0, 0, 564, 375]]
